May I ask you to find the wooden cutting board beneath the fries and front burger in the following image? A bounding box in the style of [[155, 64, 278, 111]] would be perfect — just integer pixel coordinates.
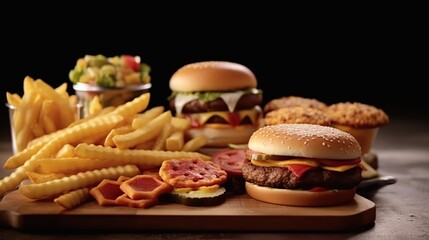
[[0, 191, 375, 231]]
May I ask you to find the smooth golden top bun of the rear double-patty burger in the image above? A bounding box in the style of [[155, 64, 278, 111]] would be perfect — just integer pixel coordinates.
[[170, 61, 257, 92]]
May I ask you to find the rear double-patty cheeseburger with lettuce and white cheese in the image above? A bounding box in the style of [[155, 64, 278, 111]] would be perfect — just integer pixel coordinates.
[[169, 61, 262, 147]]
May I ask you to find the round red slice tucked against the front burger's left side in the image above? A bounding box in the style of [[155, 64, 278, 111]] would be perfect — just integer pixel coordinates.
[[212, 149, 249, 175]]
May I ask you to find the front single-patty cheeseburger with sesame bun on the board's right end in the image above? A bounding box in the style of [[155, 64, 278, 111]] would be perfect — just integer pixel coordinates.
[[242, 124, 362, 206]]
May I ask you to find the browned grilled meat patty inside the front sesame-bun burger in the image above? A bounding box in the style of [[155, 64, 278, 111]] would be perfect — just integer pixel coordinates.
[[242, 162, 362, 189]]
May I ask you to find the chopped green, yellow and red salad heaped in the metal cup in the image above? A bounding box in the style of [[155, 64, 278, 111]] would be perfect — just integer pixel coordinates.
[[69, 54, 151, 87]]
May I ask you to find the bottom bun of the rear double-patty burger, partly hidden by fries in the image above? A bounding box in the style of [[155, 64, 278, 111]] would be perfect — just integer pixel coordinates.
[[186, 125, 257, 147]]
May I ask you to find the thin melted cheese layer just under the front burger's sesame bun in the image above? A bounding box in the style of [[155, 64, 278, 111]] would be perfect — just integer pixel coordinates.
[[251, 158, 359, 172]]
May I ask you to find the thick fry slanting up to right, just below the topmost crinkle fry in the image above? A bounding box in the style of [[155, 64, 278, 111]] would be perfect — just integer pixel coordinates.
[[113, 111, 172, 149]]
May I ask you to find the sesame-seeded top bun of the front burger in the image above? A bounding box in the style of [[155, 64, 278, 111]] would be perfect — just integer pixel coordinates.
[[248, 124, 361, 160]]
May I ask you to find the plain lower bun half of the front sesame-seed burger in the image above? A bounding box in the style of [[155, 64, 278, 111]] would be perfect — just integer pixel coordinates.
[[245, 182, 356, 207]]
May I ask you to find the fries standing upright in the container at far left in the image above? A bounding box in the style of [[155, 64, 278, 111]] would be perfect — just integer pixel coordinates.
[[6, 76, 77, 151]]
